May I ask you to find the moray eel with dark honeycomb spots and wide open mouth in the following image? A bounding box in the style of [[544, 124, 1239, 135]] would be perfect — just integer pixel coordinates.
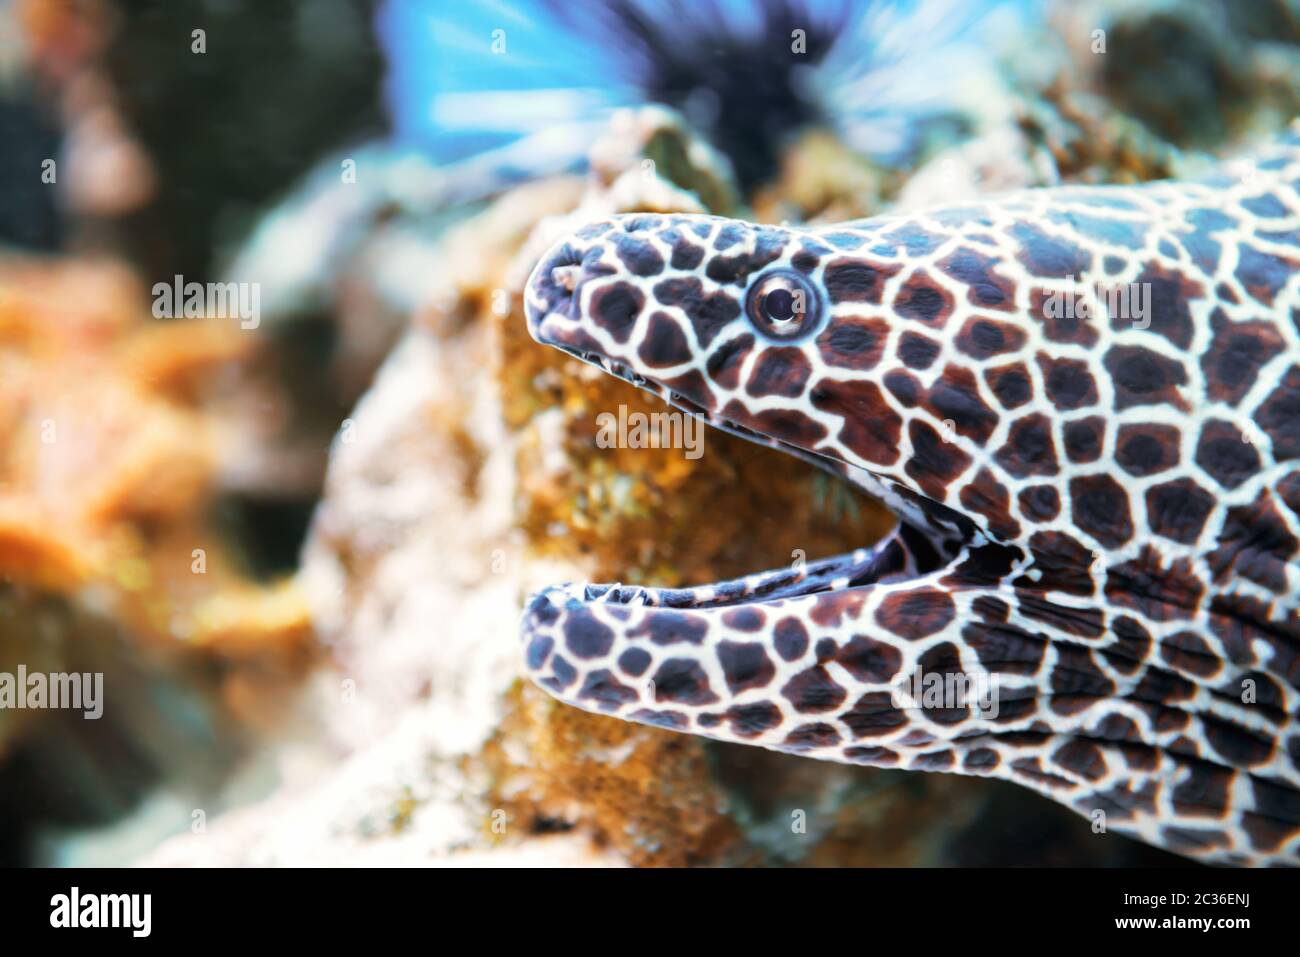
[[523, 125, 1300, 865]]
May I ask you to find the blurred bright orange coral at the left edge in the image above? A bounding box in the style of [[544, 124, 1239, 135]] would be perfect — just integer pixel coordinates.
[[0, 260, 309, 657]]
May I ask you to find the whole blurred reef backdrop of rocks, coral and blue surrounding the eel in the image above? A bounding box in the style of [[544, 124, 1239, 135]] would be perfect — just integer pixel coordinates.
[[0, 0, 1300, 866]]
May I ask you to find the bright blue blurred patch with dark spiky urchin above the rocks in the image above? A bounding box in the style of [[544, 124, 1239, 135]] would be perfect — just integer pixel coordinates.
[[377, 0, 1037, 187]]
